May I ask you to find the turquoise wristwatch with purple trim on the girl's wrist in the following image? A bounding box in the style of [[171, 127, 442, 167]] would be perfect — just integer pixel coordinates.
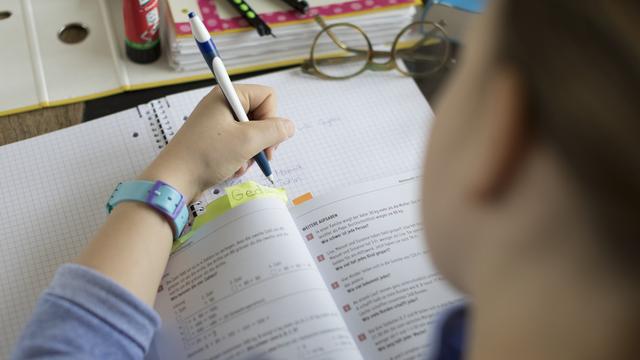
[[107, 180, 189, 239]]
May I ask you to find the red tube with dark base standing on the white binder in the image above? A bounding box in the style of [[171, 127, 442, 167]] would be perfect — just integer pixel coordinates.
[[122, 0, 161, 64]]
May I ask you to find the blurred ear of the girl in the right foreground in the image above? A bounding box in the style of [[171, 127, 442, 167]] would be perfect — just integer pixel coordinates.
[[471, 69, 530, 200]]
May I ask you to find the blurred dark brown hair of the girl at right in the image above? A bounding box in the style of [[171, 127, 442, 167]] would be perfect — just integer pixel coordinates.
[[498, 0, 640, 276]]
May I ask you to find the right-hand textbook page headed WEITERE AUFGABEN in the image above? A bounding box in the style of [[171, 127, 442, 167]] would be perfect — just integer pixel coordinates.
[[291, 174, 461, 360]]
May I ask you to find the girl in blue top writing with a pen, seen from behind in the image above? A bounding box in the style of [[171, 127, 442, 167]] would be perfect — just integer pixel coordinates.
[[14, 0, 640, 360]]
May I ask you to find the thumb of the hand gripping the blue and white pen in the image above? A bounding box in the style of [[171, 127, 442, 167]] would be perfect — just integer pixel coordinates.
[[240, 118, 295, 154]]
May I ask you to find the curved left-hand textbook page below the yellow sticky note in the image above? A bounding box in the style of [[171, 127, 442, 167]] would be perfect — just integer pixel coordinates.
[[149, 199, 361, 360]]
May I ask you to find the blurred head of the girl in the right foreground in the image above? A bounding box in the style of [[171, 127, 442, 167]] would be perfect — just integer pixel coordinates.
[[424, 0, 640, 295]]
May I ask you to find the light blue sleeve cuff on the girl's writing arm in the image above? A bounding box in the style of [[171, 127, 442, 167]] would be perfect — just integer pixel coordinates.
[[12, 264, 160, 359]]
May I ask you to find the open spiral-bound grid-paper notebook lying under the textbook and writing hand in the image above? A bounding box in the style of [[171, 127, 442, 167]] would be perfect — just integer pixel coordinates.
[[0, 69, 432, 358]]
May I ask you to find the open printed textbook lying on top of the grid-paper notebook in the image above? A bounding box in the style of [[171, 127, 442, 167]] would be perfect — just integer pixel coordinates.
[[150, 174, 460, 360]]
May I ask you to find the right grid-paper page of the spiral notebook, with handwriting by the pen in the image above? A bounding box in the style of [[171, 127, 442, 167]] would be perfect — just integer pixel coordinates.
[[167, 69, 433, 203]]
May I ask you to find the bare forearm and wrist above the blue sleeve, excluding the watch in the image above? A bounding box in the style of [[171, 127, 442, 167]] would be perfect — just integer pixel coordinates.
[[76, 159, 197, 306]]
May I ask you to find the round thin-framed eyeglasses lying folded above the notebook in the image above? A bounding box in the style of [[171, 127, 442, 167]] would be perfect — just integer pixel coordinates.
[[302, 16, 451, 79]]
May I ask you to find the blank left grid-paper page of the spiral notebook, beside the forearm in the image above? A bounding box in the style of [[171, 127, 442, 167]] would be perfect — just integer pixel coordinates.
[[0, 106, 158, 359]]
